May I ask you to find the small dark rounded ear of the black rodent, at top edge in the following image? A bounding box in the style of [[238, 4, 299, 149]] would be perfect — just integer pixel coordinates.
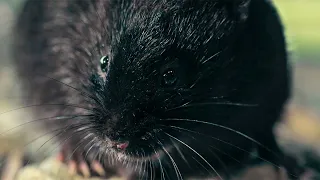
[[224, 0, 251, 22]]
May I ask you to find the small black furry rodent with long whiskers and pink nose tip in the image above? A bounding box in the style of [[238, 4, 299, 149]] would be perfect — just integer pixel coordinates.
[[14, 0, 300, 179]]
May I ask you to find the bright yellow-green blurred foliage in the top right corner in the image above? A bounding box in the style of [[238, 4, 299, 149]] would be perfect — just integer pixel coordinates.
[[274, 0, 320, 62]]
